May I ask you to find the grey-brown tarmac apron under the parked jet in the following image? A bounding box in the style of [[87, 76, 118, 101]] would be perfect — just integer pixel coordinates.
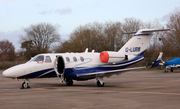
[[0, 70, 180, 109]]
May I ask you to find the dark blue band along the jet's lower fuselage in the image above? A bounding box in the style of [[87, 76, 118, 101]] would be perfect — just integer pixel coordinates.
[[18, 51, 144, 79]]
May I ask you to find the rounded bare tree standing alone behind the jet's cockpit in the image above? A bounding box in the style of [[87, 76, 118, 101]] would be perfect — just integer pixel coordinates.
[[20, 23, 60, 58]]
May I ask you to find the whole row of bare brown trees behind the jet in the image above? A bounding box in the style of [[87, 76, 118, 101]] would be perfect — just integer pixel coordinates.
[[0, 12, 180, 62]]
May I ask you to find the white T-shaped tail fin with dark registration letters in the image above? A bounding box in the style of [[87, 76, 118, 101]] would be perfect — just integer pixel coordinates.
[[118, 29, 170, 56]]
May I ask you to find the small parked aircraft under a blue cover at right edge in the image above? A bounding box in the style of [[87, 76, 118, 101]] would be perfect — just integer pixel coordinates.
[[160, 58, 180, 72]]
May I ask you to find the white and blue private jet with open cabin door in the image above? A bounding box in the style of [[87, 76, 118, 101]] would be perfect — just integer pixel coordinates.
[[3, 29, 170, 88]]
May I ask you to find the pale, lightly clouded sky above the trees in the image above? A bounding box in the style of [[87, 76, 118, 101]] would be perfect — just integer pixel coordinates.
[[0, 0, 180, 50]]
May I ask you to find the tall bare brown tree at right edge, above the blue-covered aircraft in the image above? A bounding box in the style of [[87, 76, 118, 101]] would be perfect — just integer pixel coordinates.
[[156, 12, 180, 57]]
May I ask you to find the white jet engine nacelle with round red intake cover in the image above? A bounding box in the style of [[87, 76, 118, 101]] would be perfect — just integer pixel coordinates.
[[99, 51, 128, 63]]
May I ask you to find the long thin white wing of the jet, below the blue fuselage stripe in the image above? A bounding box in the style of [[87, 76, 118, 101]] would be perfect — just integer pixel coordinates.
[[77, 66, 147, 78]]
